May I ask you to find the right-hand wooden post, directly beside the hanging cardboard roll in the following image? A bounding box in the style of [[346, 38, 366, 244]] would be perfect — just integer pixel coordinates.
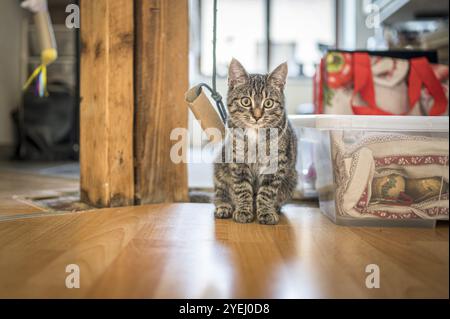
[[135, 0, 189, 204]]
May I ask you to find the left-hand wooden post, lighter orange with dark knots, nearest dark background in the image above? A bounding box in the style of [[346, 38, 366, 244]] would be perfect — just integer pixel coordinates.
[[80, 0, 134, 207]]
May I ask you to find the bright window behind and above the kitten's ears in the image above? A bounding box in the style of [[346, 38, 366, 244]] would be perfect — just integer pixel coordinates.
[[198, 0, 336, 77]]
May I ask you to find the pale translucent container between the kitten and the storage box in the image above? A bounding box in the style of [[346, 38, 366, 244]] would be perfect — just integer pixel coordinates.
[[289, 115, 318, 199]]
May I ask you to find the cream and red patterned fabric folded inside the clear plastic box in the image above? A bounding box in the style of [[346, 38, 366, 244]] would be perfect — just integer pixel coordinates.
[[331, 131, 449, 219]]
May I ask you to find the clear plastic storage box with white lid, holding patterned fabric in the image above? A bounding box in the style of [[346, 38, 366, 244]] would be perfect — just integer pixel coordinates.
[[310, 115, 449, 227]]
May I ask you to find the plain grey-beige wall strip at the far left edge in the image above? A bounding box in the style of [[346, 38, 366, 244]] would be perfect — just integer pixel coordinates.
[[0, 0, 24, 145]]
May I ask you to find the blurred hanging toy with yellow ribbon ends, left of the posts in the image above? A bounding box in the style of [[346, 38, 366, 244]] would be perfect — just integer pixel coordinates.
[[21, 0, 58, 97]]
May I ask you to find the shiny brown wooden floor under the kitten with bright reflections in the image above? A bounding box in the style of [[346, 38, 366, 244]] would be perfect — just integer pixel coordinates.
[[0, 173, 449, 298]]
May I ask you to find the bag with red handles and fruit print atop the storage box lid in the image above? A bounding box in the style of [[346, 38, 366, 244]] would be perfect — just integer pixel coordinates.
[[314, 51, 449, 115]]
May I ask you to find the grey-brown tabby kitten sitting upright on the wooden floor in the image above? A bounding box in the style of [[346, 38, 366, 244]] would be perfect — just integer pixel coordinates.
[[214, 59, 297, 224]]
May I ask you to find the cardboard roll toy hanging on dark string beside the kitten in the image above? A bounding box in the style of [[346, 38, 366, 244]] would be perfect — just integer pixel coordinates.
[[185, 0, 227, 142]]
